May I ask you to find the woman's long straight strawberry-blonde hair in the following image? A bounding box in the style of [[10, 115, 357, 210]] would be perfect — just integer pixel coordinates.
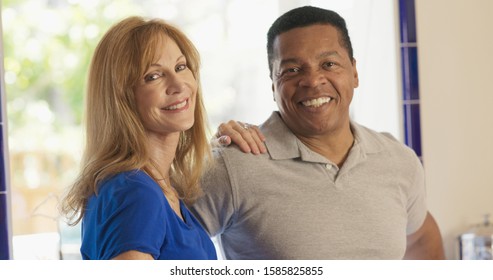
[[61, 17, 211, 225]]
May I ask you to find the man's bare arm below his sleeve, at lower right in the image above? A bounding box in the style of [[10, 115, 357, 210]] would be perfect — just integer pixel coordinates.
[[404, 212, 445, 260]]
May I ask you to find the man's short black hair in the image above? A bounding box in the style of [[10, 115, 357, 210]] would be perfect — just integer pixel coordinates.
[[267, 6, 353, 77]]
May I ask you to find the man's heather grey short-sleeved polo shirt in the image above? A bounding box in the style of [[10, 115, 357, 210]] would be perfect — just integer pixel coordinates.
[[192, 112, 427, 259]]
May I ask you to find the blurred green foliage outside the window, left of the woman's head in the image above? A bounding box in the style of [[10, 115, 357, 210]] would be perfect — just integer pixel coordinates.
[[2, 0, 139, 131]]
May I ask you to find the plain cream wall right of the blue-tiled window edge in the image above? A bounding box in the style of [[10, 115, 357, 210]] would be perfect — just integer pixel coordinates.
[[416, 0, 493, 259]]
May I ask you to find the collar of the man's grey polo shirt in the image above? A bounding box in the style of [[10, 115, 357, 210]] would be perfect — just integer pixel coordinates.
[[260, 111, 384, 163]]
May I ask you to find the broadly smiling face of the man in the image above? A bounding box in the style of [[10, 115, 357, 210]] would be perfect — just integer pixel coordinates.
[[272, 24, 358, 137]]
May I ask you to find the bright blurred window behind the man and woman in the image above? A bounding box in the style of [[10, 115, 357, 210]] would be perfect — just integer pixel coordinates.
[[1, 0, 401, 259]]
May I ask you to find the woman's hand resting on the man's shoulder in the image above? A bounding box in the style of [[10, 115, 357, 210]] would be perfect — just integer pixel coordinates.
[[212, 120, 267, 155]]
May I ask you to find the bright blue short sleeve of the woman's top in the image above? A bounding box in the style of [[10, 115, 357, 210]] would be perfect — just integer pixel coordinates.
[[97, 173, 166, 259]]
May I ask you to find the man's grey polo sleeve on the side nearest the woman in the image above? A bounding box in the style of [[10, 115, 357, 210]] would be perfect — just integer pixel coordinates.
[[190, 149, 235, 236]]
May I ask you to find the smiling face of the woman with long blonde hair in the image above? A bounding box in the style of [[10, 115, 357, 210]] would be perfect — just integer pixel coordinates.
[[135, 36, 197, 138]]
